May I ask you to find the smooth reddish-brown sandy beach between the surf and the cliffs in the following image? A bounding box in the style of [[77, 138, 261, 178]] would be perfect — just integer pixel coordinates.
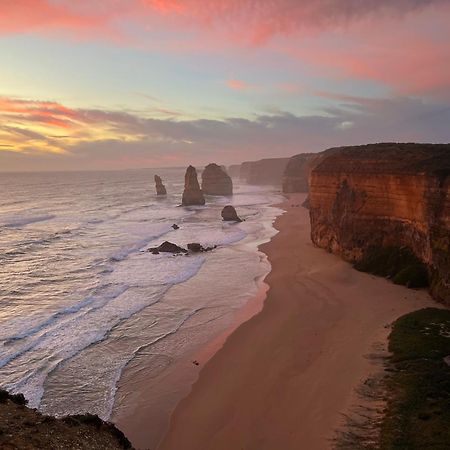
[[157, 195, 435, 450]]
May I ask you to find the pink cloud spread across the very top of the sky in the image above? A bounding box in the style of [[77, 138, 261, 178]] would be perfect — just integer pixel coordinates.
[[0, 0, 450, 95]]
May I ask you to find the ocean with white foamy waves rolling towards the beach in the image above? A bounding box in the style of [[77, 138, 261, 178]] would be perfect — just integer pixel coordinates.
[[0, 169, 281, 419]]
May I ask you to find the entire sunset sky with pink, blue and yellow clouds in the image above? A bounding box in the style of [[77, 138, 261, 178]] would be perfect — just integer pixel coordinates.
[[0, 0, 450, 171]]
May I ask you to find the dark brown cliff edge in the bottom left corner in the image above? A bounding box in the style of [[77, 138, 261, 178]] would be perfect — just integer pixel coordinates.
[[0, 390, 132, 450]]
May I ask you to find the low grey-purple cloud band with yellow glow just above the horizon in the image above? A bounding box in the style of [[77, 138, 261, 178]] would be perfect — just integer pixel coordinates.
[[0, 93, 450, 170]]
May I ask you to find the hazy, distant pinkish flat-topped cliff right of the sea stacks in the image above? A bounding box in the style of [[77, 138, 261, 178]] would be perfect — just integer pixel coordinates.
[[239, 158, 289, 186]]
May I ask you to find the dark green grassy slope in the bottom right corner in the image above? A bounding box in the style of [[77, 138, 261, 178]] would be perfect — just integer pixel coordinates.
[[379, 308, 450, 450]]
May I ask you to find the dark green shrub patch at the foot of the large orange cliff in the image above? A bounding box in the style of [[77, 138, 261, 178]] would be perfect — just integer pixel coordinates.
[[355, 247, 429, 288]]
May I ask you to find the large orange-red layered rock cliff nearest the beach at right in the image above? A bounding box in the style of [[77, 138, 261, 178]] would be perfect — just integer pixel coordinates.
[[309, 143, 450, 304]]
